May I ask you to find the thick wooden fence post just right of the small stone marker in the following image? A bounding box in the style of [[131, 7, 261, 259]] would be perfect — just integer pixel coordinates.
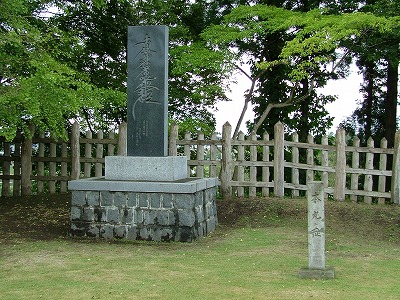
[[333, 128, 346, 201]]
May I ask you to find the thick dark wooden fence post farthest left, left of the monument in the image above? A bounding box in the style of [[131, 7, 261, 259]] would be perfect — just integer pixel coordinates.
[[21, 125, 35, 195]]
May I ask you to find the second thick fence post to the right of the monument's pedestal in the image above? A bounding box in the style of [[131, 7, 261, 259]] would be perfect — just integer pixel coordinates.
[[274, 122, 285, 197]]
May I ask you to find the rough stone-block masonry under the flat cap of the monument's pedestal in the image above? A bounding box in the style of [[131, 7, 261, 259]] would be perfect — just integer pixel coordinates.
[[71, 185, 217, 242]]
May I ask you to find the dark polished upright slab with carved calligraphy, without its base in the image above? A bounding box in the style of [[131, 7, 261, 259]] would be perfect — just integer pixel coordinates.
[[127, 26, 168, 156]]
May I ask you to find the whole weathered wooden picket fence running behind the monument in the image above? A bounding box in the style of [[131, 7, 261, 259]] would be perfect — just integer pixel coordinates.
[[0, 123, 400, 204]]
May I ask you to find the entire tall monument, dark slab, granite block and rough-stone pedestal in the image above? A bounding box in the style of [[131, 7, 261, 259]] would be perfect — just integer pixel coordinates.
[[68, 26, 219, 242]]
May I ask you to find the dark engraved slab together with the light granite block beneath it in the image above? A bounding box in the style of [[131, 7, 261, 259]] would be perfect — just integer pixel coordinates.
[[105, 26, 187, 181]]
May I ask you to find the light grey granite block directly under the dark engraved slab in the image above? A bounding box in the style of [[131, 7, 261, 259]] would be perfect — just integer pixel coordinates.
[[105, 156, 187, 181]]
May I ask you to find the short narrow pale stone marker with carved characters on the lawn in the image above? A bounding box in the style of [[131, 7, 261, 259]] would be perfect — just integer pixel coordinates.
[[299, 181, 335, 279]]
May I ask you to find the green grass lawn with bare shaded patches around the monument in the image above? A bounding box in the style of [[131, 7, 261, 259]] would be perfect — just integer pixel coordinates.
[[0, 195, 400, 299]]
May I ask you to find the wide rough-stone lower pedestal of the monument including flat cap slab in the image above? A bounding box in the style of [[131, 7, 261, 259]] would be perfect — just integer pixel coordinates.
[[69, 178, 219, 242]]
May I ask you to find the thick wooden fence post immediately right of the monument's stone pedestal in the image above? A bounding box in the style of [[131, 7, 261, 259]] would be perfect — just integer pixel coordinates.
[[221, 122, 232, 200]]
